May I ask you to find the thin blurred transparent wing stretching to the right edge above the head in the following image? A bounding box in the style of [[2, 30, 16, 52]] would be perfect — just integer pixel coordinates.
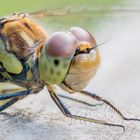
[[30, 5, 140, 18]]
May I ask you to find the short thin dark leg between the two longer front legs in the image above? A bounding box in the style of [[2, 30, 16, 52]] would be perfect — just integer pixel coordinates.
[[58, 94, 104, 107]]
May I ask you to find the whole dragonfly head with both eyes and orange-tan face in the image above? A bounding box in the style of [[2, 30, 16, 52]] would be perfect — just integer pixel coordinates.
[[38, 27, 99, 86]]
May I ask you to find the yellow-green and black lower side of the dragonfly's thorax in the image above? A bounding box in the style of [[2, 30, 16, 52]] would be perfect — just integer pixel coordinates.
[[0, 40, 36, 83]]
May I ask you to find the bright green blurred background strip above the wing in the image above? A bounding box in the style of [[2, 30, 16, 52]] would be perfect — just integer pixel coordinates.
[[0, 0, 118, 16]]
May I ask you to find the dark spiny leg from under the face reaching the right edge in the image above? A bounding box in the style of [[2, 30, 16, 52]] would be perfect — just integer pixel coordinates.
[[78, 91, 140, 121]]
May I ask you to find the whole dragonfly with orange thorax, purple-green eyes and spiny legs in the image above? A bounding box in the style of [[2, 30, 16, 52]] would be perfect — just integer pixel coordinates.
[[0, 10, 140, 130]]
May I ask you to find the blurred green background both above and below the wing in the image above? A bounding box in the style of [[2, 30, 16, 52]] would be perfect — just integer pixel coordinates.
[[0, 0, 122, 33]]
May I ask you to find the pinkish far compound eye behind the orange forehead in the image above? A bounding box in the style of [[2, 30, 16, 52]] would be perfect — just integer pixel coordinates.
[[70, 27, 96, 47]]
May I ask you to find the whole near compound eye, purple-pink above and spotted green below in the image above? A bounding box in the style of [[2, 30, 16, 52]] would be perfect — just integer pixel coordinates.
[[38, 32, 76, 84]]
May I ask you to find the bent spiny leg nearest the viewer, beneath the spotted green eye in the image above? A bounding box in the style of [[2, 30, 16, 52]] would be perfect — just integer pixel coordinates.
[[48, 86, 125, 131]]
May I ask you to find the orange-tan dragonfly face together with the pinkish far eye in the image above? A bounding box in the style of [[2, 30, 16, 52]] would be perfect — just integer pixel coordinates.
[[61, 27, 100, 91]]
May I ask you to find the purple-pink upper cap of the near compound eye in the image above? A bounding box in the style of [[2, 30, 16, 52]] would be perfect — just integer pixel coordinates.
[[45, 32, 76, 57]]
